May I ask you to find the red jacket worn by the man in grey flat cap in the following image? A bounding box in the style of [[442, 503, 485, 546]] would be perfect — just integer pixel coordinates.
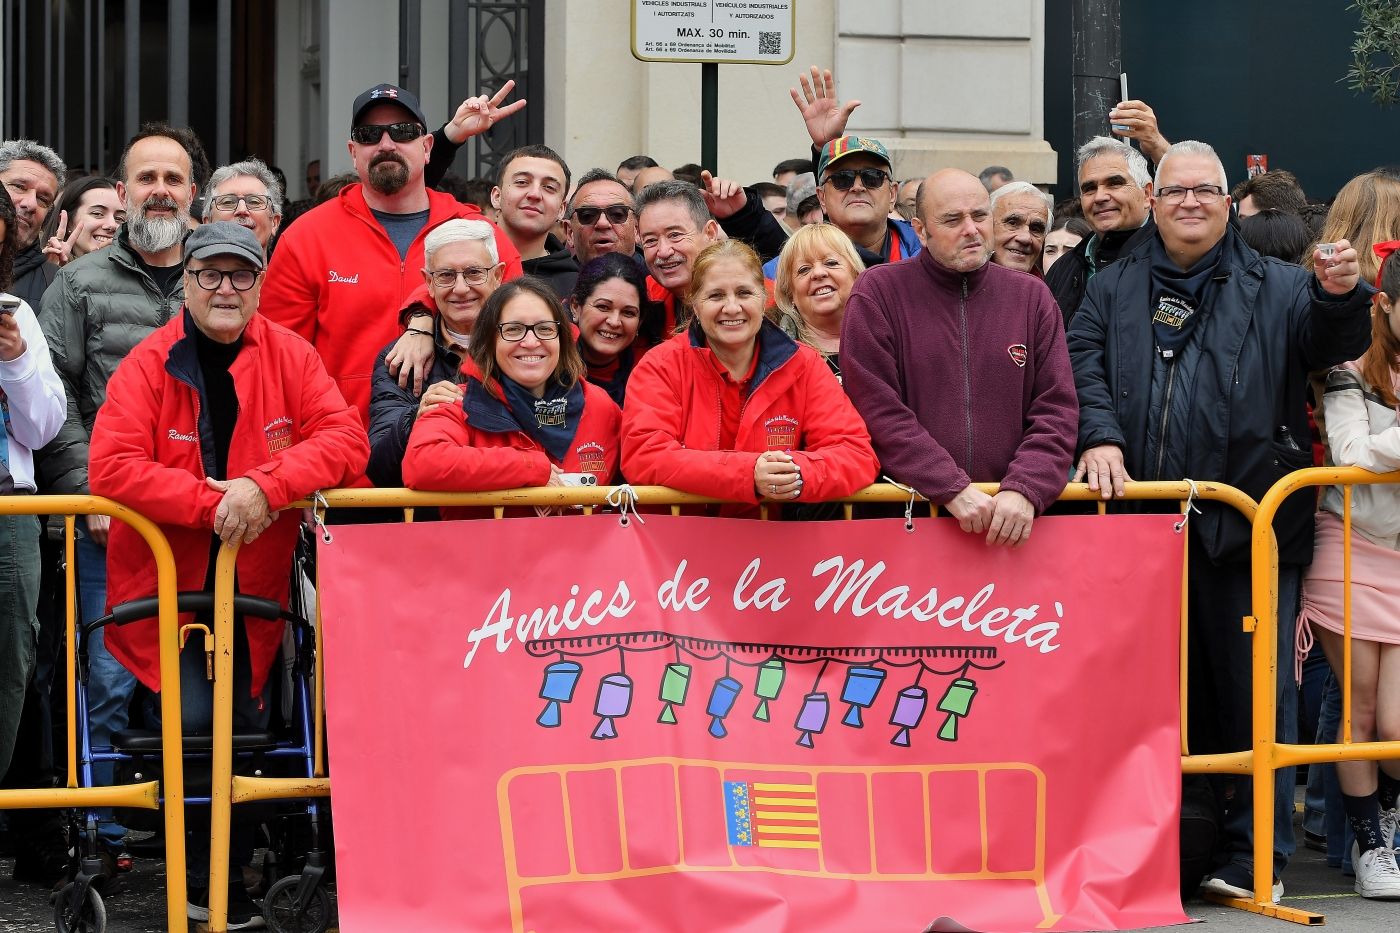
[[88, 311, 370, 696]]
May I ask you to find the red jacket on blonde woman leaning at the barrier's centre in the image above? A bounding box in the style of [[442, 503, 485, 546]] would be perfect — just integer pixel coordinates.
[[622, 321, 879, 503]]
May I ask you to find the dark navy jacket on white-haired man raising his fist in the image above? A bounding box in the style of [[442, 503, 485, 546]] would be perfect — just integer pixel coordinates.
[[1068, 230, 1375, 565]]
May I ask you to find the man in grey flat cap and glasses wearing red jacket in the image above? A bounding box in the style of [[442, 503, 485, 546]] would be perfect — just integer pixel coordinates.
[[91, 221, 370, 930]]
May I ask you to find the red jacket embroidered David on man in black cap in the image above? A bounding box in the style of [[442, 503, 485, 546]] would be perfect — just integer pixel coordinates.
[[260, 185, 521, 424]]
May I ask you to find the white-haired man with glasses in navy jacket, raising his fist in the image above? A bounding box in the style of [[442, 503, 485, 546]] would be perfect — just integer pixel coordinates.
[[1064, 140, 1373, 901]]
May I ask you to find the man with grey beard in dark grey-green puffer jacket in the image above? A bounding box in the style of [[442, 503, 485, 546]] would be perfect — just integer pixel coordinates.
[[39, 123, 203, 868]]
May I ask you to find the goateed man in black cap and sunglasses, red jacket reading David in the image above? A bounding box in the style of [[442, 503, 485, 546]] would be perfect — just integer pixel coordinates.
[[263, 84, 521, 423]]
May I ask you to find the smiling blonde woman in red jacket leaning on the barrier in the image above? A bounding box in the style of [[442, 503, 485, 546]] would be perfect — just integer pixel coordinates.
[[622, 240, 879, 503]]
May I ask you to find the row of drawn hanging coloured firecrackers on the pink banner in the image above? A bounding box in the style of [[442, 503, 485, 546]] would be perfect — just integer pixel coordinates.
[[525, 632, 1005, 748]]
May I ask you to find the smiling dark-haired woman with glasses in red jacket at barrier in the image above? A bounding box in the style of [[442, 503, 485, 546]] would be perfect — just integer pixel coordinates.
[[403, 276, 622, 501]]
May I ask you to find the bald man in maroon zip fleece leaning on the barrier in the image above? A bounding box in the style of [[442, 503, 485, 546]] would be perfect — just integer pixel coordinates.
[[841, 168, 1079, 546]]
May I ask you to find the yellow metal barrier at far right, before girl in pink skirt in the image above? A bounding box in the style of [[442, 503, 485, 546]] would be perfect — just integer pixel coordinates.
[[1221, 467, 1400, 925]]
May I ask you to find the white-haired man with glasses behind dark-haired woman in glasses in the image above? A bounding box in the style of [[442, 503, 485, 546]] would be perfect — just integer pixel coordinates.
[[367, 220, 505, 488]]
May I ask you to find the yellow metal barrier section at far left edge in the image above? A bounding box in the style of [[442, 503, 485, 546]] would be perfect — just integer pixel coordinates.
[[0, 496, 188, 933]]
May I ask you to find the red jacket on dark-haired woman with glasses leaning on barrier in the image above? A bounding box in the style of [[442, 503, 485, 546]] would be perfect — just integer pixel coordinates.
[[403, 361, 622, 518]]
